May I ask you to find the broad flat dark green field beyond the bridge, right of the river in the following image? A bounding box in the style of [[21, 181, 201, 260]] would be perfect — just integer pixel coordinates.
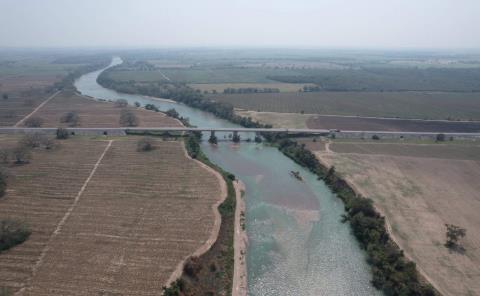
[[212, 92, 480, 120]]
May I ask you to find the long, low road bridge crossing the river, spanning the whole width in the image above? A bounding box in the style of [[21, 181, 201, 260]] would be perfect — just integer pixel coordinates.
[[0, 127, 480, 139]]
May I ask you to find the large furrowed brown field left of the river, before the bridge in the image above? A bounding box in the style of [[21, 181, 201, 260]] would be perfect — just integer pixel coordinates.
[[0, 136, 220, 295]]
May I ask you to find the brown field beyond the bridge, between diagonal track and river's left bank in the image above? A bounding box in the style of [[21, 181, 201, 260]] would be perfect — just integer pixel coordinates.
[[27, 92, 181, 127]]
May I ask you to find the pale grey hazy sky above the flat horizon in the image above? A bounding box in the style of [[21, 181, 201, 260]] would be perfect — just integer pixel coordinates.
[[0, 0, 480, 48]]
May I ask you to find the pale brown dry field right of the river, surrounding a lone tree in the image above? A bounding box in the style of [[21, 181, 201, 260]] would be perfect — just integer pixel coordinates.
[[316, 142, 480, 295]]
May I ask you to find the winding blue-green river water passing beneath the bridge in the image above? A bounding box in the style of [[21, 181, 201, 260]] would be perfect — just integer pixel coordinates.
[[75, 58, 381, 296]]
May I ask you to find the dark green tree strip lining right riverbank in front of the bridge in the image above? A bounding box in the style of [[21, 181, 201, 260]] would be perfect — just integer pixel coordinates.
[[270, 135, 436, 296]]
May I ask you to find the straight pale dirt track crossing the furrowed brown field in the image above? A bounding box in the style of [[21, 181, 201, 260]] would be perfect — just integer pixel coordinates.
[[15, 140, 113, 295]]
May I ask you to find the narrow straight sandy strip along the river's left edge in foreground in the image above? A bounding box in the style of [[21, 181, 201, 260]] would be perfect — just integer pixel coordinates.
[[232, 181, 248, 296]]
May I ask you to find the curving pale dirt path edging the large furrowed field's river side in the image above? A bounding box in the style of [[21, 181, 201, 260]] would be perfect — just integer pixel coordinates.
[[165, 141, 228, 287]]
